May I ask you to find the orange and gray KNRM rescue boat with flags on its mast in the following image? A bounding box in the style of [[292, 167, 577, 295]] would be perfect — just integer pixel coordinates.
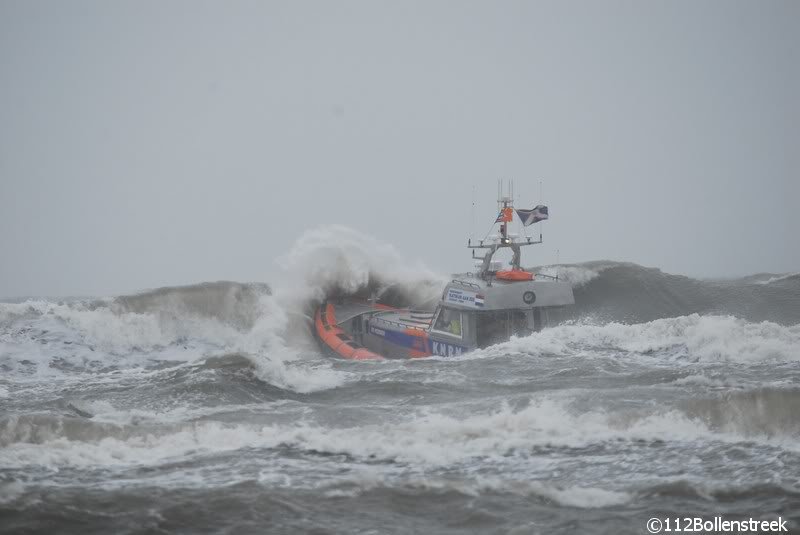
[[314, 186, 575, 360]]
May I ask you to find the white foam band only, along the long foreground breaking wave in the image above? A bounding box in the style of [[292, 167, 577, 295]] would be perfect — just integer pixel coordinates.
[[0, 398, 796, 472]]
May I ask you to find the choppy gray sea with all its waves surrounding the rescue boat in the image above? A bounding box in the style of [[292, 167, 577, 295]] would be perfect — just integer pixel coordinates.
[[0, 232, 800, 534]]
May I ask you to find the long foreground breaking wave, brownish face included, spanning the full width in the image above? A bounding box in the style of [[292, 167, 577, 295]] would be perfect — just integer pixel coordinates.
[[0, 392, 798, 467]]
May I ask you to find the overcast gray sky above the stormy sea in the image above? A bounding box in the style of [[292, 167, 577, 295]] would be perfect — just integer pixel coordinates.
[[0, 0, 800, 296]]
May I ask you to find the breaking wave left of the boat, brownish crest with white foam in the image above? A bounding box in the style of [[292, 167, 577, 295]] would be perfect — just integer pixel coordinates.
[[0, 282, 343, 392]]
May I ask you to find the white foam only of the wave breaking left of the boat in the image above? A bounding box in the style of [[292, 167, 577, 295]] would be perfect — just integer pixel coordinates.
[[0, 288, 348, 393]]
